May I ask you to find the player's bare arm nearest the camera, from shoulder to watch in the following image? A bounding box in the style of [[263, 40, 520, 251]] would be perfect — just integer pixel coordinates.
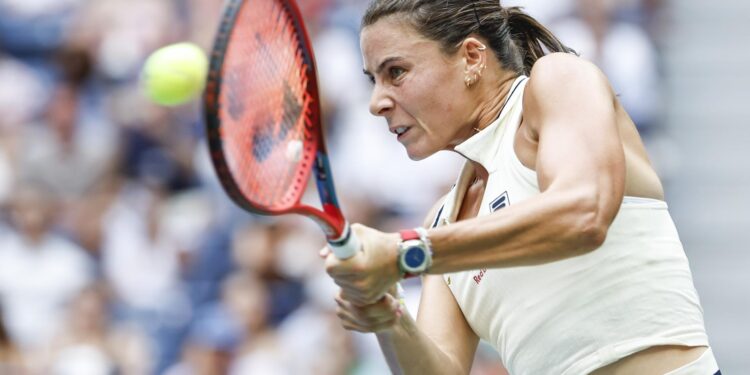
[[429, 54, 625, 273]]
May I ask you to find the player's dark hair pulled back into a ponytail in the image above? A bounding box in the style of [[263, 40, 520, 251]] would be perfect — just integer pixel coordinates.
[[361, 0, 575, 74]]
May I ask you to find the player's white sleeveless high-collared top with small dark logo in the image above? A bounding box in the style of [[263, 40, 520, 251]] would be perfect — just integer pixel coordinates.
[[433, 76, 708, 375]]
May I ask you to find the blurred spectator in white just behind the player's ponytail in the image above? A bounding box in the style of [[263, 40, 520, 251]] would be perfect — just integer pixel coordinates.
[[552, 0, 661, 137]]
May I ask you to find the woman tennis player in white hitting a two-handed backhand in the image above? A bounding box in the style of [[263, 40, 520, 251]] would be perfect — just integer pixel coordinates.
[[322, 0, 719, 375]]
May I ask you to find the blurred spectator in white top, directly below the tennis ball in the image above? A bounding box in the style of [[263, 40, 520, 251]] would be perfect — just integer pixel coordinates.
[[101, 181, 192, 371]]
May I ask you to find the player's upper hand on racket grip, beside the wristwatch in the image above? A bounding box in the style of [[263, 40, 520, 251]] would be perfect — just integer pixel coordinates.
[[320, 224, 401, 307]]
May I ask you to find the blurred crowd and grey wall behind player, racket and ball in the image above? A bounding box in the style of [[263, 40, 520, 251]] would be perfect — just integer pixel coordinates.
[[0, 0, 750, 375]]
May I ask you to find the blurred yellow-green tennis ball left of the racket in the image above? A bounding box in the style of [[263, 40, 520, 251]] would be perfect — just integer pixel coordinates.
[[141, 43, 208, 106]]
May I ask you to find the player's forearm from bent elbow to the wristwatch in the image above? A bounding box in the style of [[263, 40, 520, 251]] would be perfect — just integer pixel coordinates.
[[429, 192, 613, 274]]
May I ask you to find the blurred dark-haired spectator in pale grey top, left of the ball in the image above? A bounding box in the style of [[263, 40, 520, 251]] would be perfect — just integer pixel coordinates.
[[16, 44, 117, 204]]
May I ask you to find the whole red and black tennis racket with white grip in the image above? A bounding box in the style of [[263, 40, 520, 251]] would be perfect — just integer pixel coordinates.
[[203, 0, 359, 259]]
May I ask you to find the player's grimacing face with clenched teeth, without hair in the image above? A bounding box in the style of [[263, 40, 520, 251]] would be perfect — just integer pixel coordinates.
[[360, 16, 472, 160]]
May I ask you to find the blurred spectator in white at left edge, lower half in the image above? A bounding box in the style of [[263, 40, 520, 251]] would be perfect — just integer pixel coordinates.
[[0, 183, 94, 351]]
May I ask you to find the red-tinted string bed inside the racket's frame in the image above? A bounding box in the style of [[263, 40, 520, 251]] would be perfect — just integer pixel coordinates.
[[219, 0, 317, 209]]
